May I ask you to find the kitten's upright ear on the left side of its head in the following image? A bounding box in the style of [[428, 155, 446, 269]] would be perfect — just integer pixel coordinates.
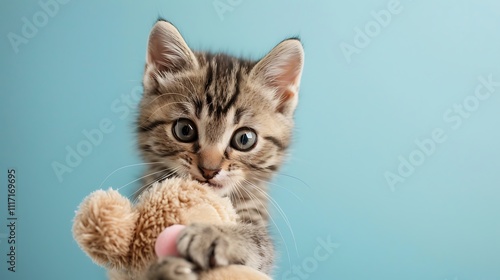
[[146, 20, 197, 74]]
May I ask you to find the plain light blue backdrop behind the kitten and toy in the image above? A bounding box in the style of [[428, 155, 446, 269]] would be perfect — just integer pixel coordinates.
[[0, 0, 500, 280]]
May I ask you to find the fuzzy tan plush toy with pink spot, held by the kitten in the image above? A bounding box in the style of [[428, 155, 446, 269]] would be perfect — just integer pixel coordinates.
[[73, 179, 271, 280]]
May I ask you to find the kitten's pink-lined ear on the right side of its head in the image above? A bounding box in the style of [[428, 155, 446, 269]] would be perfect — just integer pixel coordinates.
[[250, 39, 304, 115]]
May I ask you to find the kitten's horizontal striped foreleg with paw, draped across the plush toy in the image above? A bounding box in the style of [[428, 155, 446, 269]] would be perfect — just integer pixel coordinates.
[[177, 223, 274, 273]]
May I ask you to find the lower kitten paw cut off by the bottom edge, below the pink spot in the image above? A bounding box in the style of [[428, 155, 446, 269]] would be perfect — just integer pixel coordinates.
[[146, 257, 198, 280]]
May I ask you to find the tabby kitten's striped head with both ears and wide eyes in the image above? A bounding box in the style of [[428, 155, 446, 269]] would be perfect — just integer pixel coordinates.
[[138, 21, 304, 195]]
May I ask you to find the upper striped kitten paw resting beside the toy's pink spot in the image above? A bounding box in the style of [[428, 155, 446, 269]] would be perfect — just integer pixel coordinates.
[[177, 224, 246, 270]]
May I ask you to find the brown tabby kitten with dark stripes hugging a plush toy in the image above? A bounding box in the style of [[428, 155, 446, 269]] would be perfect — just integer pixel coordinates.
[[138, 20, 304, 279]]
